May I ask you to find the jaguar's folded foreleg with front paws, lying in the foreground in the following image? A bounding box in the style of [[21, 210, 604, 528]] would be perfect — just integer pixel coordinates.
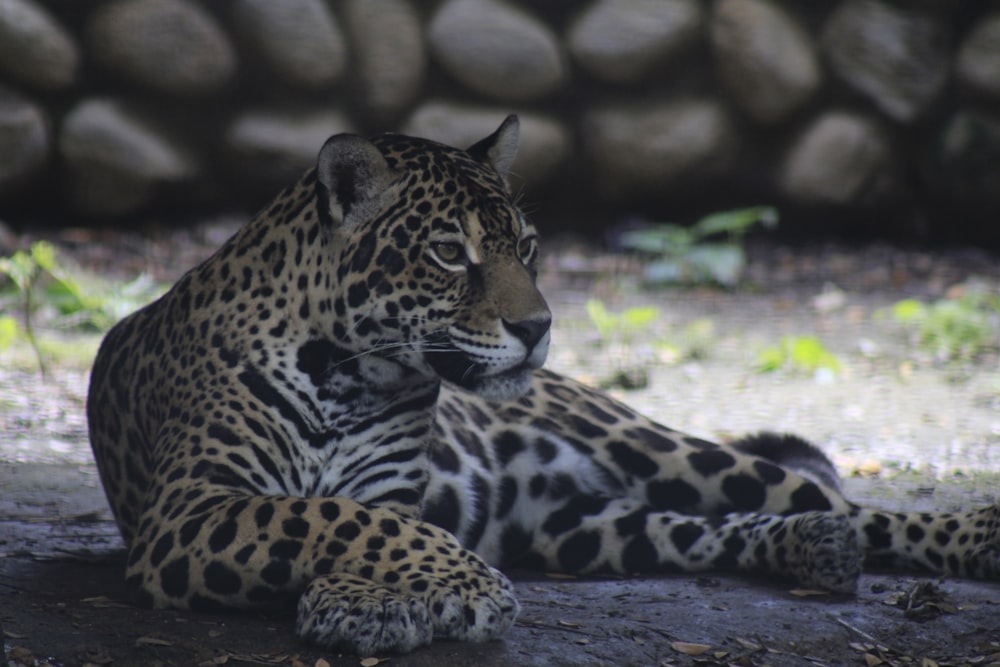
[[126, 487, 518, 654]]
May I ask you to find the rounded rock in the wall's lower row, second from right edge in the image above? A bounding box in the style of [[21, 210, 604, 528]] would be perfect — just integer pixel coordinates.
[[778, 111, 897, 205]]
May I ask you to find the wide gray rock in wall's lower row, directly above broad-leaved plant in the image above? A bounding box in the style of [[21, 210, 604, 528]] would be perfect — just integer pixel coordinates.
[[580, 98, 737, 195]]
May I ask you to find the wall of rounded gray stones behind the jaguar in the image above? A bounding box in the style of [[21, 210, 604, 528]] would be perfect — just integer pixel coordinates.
[[0, 0, 1000, 245]]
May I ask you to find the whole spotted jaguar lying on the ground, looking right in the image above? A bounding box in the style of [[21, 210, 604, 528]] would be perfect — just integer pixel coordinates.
[[87, 116, 1000, 655]]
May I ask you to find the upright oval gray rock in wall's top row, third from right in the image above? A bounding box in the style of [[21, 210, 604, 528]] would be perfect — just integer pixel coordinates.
[[711, 0, 822, 125]]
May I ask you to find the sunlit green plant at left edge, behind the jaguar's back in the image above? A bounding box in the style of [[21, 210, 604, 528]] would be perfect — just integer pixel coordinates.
[[0, 241, 162, 376]]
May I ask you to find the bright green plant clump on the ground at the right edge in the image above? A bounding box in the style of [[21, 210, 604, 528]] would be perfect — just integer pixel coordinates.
[[890, 289, 1000, 361]]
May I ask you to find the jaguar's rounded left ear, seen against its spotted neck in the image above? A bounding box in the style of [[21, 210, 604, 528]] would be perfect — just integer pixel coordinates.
[[316, 134, 396, 226]]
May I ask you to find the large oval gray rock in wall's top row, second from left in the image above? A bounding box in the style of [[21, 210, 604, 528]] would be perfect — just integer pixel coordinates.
[[86, 0, 236, 96]]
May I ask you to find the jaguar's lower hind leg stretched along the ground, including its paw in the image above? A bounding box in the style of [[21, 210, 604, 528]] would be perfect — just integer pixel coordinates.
[[502, 496, 862, 593]]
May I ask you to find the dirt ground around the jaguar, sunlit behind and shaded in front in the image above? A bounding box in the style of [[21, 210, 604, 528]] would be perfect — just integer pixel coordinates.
[[0, 225, 1000, 667]]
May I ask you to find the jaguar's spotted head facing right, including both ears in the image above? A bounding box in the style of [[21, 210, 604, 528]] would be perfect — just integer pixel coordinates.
[[316, 116, 552, 401]]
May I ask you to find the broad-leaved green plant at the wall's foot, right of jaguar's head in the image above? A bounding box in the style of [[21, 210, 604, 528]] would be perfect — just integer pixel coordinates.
[[620, 206, 778, 286]]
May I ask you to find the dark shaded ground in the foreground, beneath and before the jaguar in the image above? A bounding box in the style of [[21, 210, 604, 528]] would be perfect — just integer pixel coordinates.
[[0, 464, 1000, 667]]
